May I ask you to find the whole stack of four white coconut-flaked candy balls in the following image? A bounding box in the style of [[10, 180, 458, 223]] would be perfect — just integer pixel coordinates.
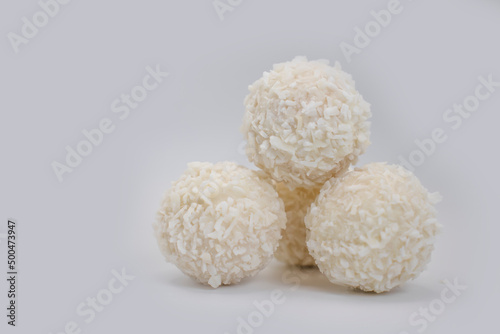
[[154, 57, 440, 293]]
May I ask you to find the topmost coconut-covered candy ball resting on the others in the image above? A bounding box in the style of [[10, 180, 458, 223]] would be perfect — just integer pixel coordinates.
[[241, 57, 371, 189]]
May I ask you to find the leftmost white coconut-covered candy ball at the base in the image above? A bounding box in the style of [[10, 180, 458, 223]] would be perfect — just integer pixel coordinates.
[[154, 162, 286, 288]]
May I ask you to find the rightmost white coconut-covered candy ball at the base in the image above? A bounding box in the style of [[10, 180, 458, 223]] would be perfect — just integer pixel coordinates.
[[305, 163, 441, 293]]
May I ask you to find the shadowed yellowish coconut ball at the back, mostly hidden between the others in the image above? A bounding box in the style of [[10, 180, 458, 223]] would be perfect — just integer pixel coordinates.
[[274, 183, 320, 267]]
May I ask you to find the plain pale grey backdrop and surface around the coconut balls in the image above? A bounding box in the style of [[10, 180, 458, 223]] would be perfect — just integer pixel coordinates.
[[0, 0, 500, 334]]
